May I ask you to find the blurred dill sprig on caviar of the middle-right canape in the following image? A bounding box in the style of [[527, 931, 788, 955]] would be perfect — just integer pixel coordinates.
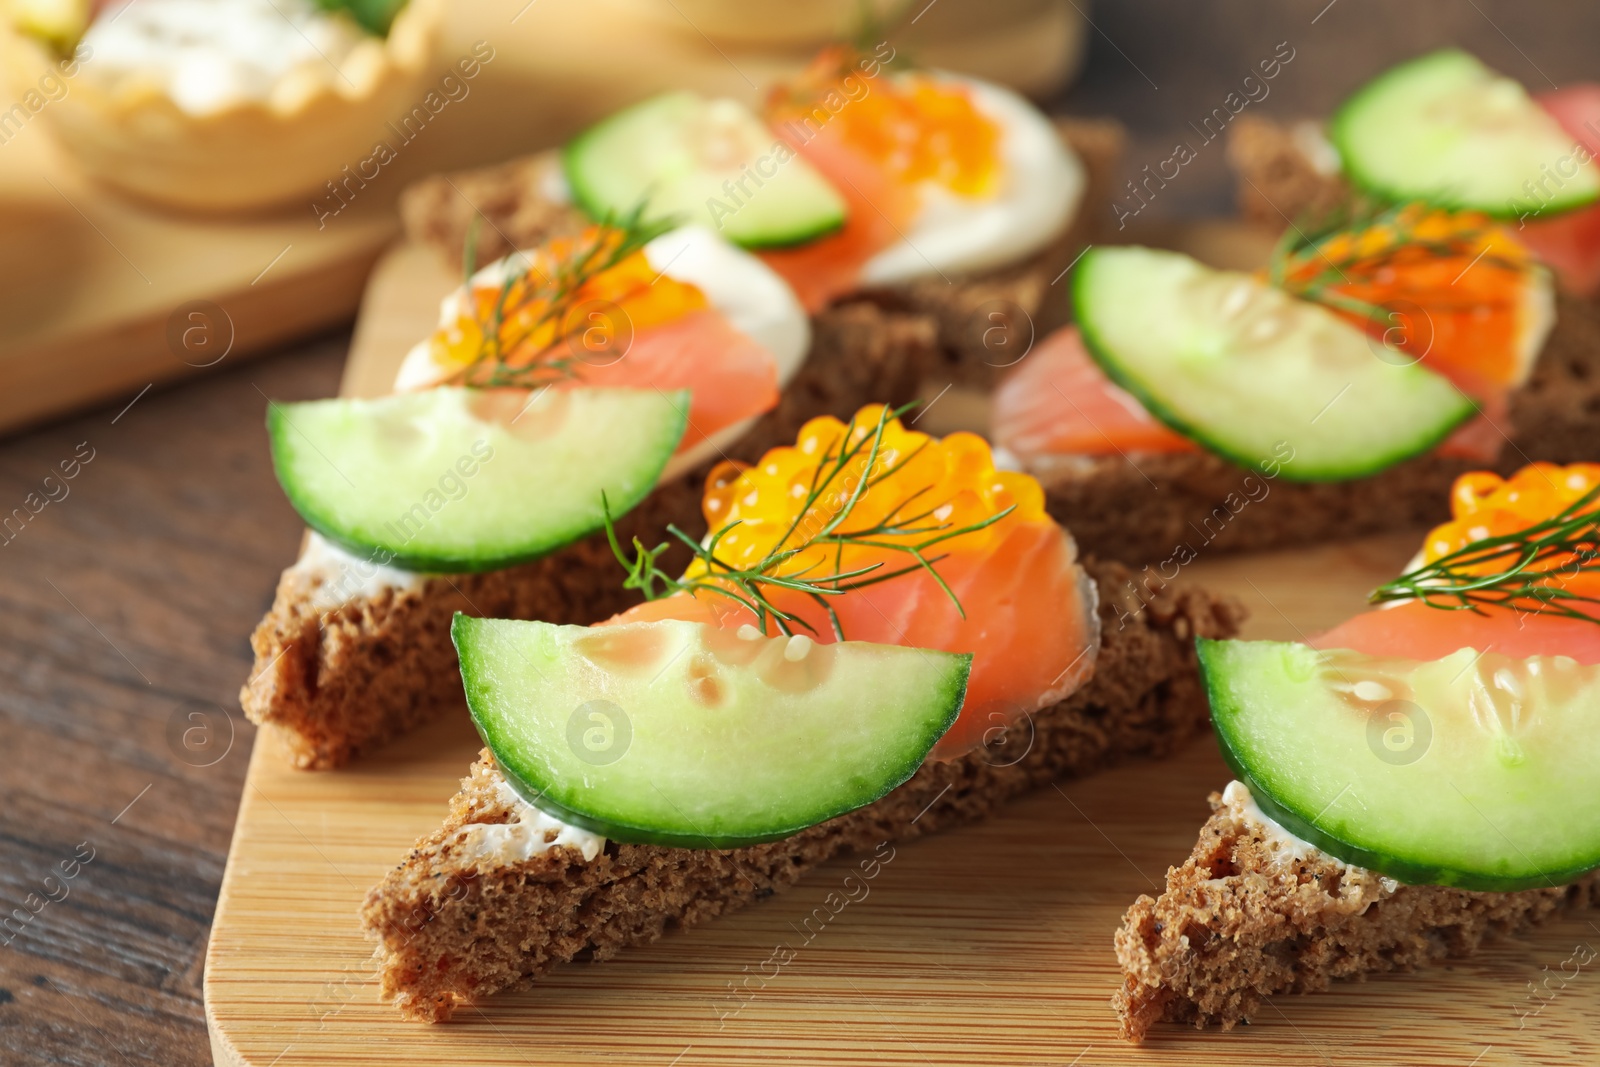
[[1267, 200, 1523, 328]]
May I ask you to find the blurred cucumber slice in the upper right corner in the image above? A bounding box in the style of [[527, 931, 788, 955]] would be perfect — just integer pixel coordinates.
[[1330, 48, 1600, 218]]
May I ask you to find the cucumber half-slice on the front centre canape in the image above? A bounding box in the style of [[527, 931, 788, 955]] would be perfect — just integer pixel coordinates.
[[451, 614, 973, 848]]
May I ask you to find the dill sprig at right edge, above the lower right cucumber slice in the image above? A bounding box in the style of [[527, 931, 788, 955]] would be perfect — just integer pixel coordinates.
[[1371, 486, 1600, 622]]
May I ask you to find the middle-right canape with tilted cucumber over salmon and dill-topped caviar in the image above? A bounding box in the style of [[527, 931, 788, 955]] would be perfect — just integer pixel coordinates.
[[992, 203, 1600, 563]]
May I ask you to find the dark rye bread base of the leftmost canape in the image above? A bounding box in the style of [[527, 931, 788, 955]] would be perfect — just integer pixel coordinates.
[[240, 301, 934, 769]]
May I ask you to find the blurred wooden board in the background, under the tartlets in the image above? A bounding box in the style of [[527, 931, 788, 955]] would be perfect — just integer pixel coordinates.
[[0, 0, 1083, 432]]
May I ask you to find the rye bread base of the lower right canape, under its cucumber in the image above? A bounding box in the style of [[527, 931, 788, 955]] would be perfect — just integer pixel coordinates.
[[1112, 793, 1600, 1041]]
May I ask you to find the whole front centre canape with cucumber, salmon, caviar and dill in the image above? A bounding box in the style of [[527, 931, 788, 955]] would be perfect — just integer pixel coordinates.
[[362, 406, 1238, 1021]]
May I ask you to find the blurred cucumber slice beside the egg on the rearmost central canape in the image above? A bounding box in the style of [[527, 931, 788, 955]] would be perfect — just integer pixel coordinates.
[[562, 93, 846, 248]]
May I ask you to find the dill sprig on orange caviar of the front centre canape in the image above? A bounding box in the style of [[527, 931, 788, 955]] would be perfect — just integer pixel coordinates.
[[602, 403, 1016, 640]]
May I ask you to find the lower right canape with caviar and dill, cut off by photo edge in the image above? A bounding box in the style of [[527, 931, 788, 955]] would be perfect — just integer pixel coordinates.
[[1114, 464, 1600, 1038]]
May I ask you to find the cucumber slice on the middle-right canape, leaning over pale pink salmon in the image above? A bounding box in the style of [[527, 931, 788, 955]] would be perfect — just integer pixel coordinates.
[[1072, 246, 1477, 482]]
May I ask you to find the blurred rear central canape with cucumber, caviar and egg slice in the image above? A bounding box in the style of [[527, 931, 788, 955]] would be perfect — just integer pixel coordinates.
[[402, 43, 1122, 386]]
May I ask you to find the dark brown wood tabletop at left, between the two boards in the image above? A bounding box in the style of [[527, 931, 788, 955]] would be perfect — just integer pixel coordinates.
[[0, 336, 347, 1067]]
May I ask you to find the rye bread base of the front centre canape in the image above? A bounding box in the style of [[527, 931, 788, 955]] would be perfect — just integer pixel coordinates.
[[362, 561, 1242, 1022]]
